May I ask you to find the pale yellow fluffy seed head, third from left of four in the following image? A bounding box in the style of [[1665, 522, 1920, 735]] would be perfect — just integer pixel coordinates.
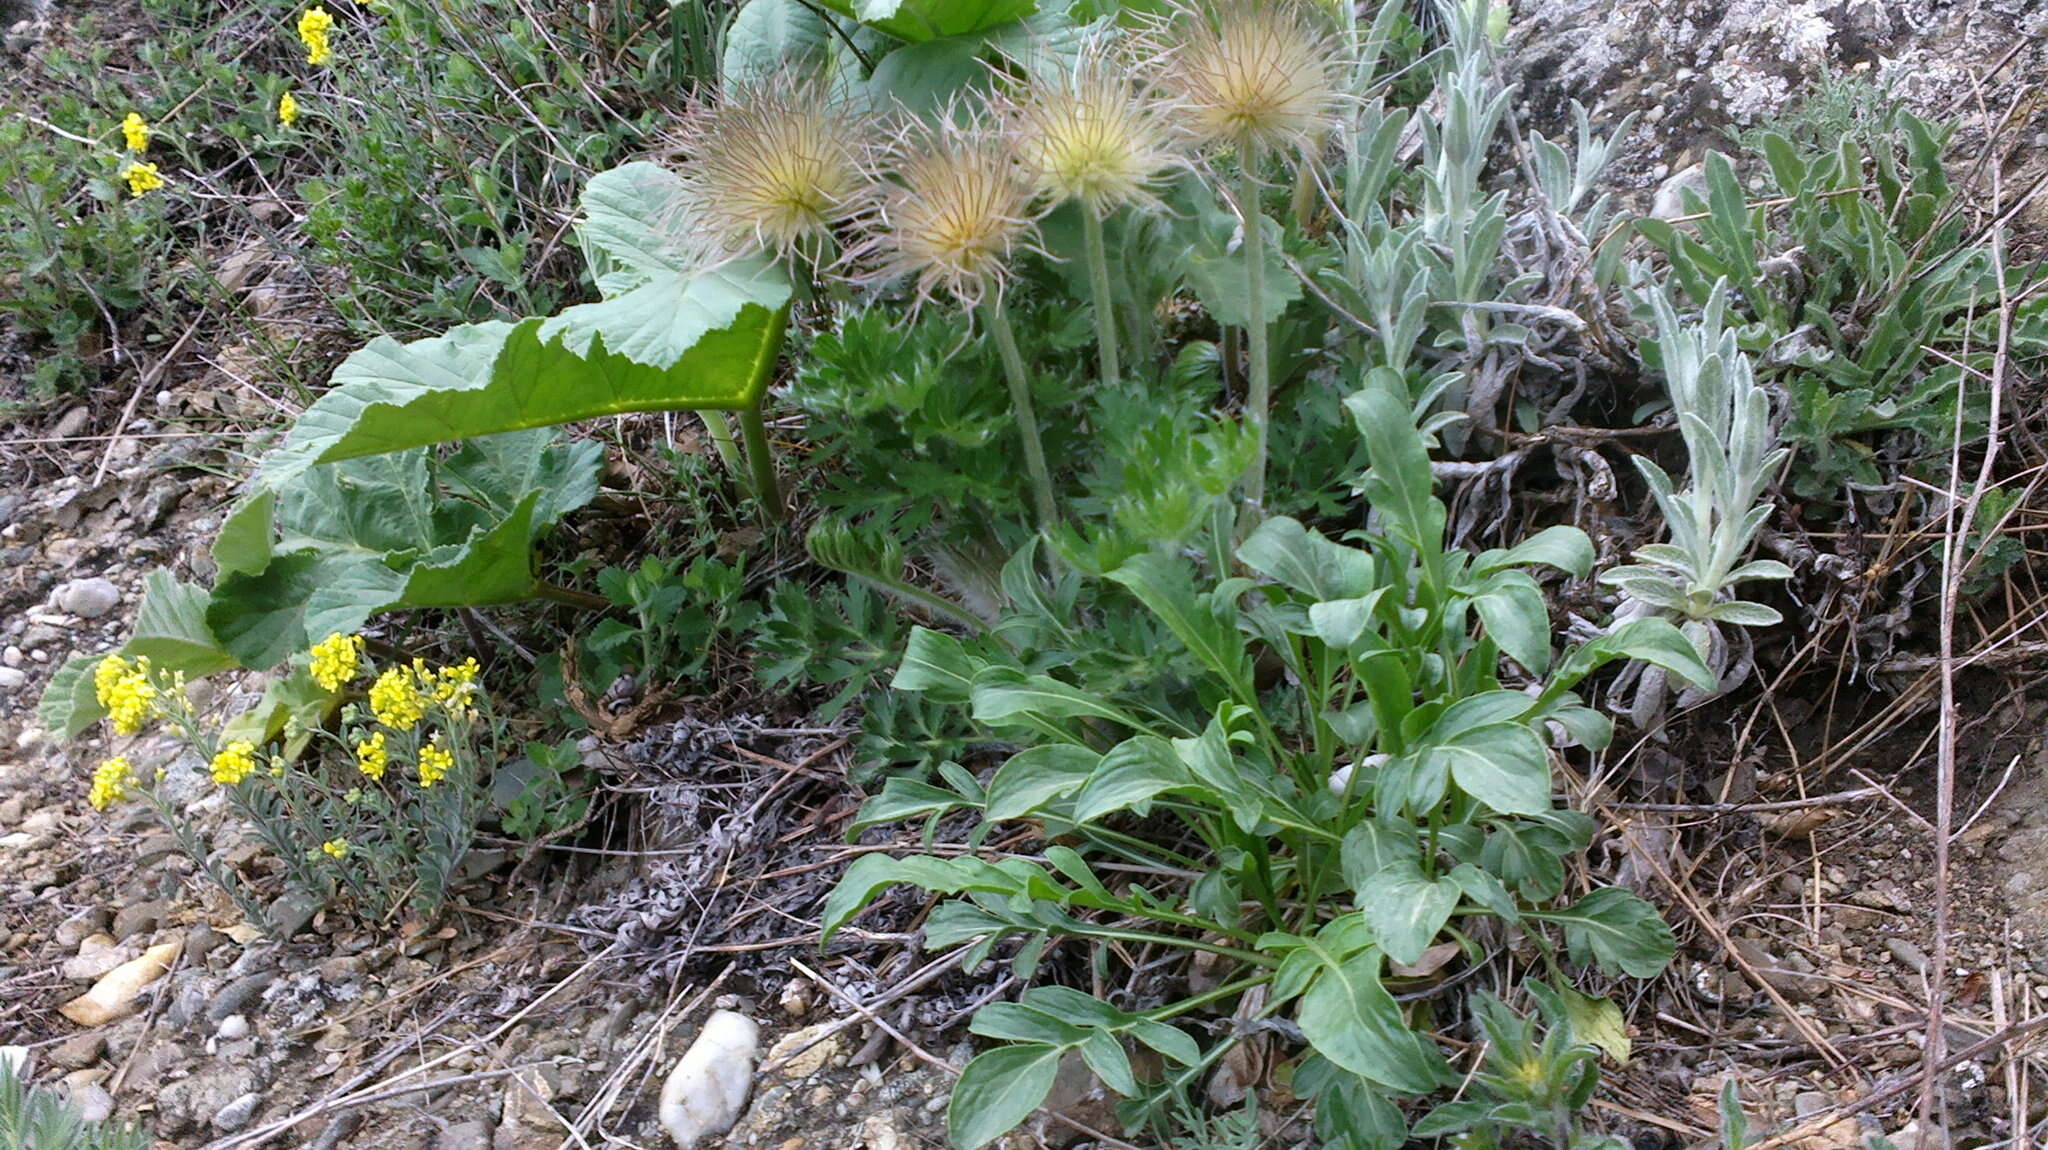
[[1001, 43, 1180, 215]]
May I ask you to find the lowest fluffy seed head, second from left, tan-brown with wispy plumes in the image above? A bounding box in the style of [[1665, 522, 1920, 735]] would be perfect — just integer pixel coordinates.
[[852, 115, 1032, 307]]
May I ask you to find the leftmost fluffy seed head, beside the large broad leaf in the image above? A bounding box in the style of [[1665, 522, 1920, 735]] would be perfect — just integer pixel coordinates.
[[672, 80, 872, 258]]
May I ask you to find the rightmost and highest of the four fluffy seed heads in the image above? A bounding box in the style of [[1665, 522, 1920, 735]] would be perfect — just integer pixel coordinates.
[[1147, 0, 1339, 151]]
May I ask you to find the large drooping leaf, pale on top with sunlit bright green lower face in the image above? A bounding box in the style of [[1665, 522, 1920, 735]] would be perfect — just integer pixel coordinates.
[[262, 262, 788, 487]]
